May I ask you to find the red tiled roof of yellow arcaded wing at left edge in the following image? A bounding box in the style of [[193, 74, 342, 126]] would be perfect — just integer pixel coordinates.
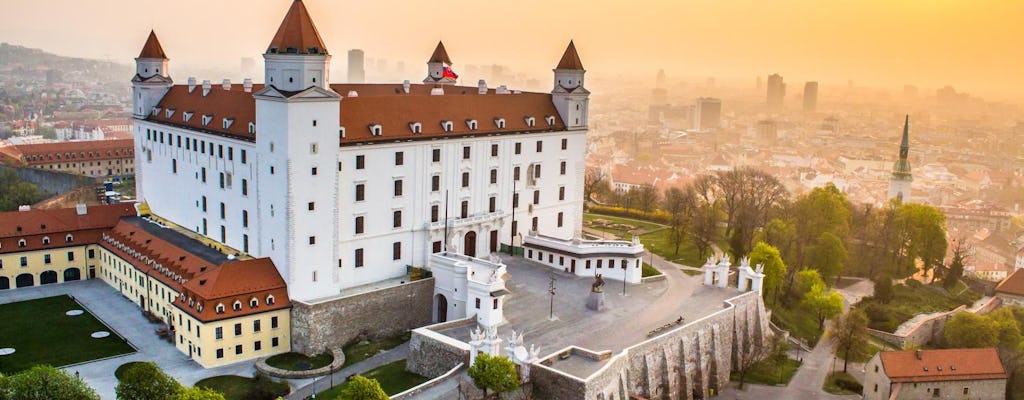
[[0, 204, 136, 254]]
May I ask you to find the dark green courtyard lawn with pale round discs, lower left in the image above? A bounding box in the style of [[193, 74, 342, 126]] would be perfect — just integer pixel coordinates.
[[0, 296, 135, 374]]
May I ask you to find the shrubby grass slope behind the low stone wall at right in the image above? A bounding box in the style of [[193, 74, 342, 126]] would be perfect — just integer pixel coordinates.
[[856, 283, 981, 332]]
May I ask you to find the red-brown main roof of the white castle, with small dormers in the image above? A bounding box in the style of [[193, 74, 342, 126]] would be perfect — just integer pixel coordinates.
[[147, 84, 565, 143]]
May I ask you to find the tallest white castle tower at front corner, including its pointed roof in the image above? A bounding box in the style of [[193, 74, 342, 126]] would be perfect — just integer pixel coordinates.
[[254, 0, 342, 301]]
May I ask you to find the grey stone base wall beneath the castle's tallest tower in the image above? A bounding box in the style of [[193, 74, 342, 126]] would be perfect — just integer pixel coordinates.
[[292, 278, 434, 353]]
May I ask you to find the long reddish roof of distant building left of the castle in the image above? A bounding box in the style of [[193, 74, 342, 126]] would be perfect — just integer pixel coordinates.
[[0, 139, 135, 165]]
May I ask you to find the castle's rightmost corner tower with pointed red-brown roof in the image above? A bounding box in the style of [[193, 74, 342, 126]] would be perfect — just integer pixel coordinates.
[[551, 41, 590, 130]]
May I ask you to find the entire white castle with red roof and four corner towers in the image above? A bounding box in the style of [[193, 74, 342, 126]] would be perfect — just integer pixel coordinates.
[[132, 0, 590, 301]]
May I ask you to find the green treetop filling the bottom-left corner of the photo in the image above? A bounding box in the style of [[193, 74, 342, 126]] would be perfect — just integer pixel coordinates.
[[0, 365, 99, 400]]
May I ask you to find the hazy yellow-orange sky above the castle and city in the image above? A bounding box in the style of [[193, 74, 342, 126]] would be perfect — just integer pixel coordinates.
[[0, 0, 1024, 99]]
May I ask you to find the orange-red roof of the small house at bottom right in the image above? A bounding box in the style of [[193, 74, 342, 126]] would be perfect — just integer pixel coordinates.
[[879, 348, 1007, 383]]
